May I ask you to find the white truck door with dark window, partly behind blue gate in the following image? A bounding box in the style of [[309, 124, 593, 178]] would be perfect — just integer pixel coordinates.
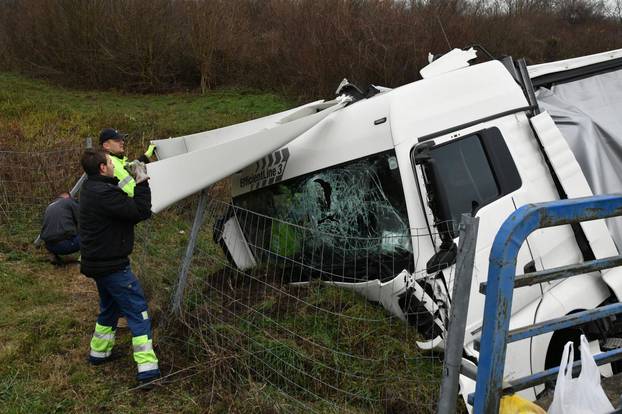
[[398, 113, 599, 388]]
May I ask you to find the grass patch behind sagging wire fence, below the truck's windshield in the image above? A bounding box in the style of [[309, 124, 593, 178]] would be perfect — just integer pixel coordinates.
[[178, 236, 442, 413]]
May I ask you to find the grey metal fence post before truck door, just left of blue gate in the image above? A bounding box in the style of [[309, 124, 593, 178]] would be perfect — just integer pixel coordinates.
[[437, 214, 479, 414]]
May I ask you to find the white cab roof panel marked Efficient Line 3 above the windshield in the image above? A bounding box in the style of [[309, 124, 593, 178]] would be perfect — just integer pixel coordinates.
[[232, 61, 528, 196]]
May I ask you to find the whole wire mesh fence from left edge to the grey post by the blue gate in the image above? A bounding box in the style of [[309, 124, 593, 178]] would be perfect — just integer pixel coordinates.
[[0, 146, 468, 413]]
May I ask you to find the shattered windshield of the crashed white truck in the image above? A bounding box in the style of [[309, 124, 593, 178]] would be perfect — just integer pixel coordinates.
[[234, 151, 413, 281]]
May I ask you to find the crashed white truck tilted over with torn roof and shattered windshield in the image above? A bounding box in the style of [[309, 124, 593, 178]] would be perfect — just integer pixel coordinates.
[[148, 49, 622, 399]]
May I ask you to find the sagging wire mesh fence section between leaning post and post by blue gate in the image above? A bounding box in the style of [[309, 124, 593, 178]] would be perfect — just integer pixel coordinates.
[[171, 200, 458, 412]]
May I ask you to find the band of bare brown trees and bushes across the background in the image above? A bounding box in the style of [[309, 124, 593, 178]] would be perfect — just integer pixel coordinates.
[[0, 0, 622, 97]]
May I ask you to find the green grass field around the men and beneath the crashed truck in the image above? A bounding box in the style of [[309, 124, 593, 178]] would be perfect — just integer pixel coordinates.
[[0, 73, 448, 413]]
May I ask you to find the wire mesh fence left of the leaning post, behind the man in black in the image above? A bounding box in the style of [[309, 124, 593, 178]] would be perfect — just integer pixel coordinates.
[[0, 143, 196, 310]]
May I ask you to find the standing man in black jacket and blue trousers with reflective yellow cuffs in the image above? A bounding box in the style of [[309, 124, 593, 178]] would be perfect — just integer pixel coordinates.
[[80, 150, 160, 389]]
